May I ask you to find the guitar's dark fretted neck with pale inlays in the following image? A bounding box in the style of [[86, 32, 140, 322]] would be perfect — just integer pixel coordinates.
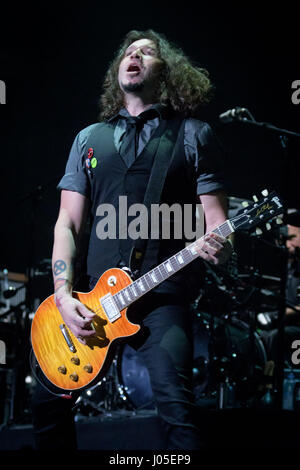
[[113, 220, 234, 310]]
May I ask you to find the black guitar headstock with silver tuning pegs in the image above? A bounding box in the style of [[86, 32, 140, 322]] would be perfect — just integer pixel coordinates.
[[229, 189, 284, 235]]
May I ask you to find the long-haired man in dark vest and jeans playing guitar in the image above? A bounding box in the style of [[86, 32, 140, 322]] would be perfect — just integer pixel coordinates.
[[33, 30, 231, 449]]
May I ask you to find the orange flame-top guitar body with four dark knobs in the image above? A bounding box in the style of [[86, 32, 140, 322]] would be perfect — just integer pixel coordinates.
[[31, 268, 140, 391]]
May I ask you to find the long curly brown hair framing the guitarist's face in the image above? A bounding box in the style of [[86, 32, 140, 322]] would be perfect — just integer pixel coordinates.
[[99, 29, 213, 121]]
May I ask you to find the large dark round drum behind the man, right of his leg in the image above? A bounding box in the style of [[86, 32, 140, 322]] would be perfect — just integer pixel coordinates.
[[193, 312, 267, 401]]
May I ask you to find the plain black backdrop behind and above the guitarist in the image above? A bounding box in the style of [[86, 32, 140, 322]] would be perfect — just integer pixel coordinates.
[[0, 2, 300, 272]]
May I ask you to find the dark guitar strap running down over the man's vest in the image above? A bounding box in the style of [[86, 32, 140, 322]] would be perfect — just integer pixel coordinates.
[[129, 117, 185, 278]]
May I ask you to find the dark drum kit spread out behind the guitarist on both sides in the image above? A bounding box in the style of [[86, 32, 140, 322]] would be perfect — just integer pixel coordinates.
[[0, 198, 298, 427]]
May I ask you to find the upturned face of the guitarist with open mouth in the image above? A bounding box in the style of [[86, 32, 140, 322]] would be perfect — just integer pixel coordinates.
[[118, 39, 163, 93]]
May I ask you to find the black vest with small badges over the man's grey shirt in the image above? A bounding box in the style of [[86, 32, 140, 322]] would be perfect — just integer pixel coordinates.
[[86, 116, 196, 278]]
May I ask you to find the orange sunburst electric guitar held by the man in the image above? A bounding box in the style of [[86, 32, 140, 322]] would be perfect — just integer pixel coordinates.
[[31, 192, 283, 392]]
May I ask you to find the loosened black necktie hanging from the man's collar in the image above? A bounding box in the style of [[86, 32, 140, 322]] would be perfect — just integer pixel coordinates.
[[120, 116, 144, 167]]
